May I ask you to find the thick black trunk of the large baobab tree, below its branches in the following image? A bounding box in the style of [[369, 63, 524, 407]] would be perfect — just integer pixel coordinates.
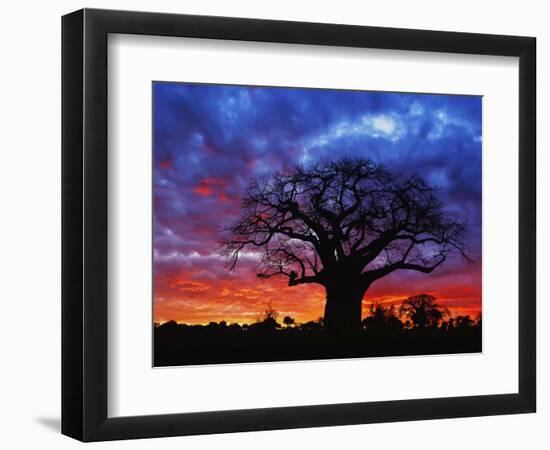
[[324, 280, 366, 336]]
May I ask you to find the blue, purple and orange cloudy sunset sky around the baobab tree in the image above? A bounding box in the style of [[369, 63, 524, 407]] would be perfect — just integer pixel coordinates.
[[153, 82, 481, 323]]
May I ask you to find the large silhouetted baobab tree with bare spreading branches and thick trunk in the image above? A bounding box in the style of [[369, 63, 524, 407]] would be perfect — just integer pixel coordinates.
[[222, 159, 467, 335]]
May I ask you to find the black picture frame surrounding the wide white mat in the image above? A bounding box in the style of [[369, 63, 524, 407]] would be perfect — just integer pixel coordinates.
[[62, 9, 536, 441]]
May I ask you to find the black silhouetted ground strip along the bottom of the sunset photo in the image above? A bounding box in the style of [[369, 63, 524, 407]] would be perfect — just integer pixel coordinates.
[[154, 322, 481, 367]]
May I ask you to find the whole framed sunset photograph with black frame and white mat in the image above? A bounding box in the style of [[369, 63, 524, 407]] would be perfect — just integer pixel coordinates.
[[62, 9, 536, 441]]
